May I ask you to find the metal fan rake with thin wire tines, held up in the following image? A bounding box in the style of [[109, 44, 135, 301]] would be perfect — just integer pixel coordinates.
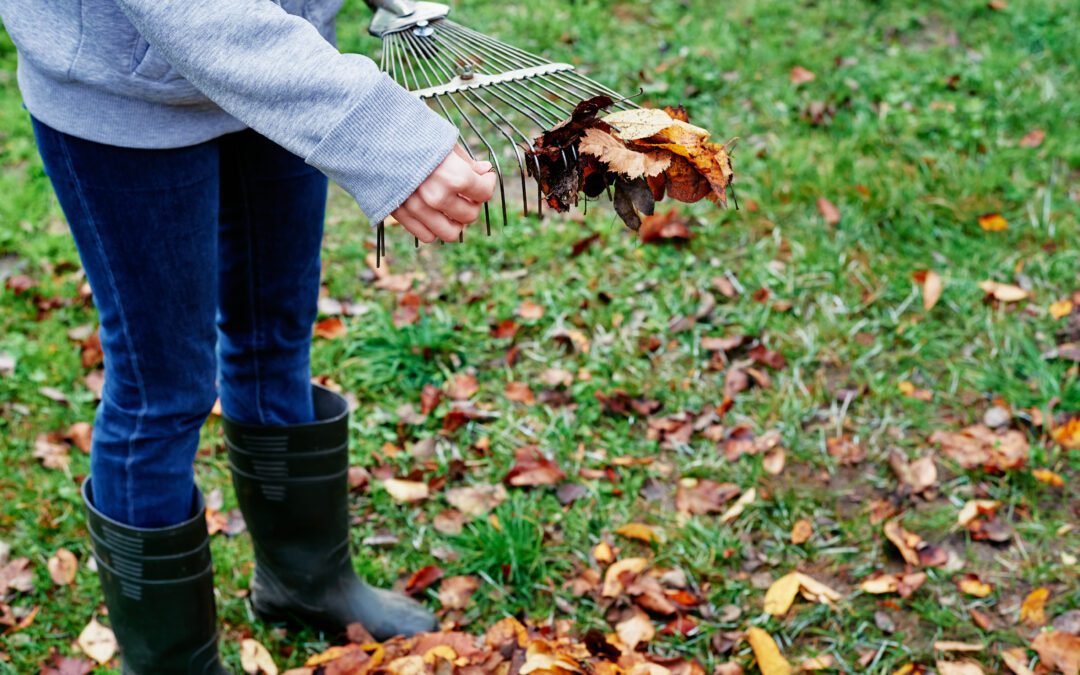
[[365, 0, 636, 265]]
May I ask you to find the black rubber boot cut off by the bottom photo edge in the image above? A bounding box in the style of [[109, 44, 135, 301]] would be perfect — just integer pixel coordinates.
[[82, 478, 228, 675]]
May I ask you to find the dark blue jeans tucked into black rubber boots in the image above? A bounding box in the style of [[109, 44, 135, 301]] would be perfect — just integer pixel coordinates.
[[33, 120, 326, 527]]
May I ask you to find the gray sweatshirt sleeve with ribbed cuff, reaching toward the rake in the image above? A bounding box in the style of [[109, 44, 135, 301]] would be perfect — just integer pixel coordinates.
[[117, 0, 458, 222]]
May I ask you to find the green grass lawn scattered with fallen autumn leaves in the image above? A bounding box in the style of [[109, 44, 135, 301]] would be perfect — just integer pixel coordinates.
[[0, 0, 1080, 673]]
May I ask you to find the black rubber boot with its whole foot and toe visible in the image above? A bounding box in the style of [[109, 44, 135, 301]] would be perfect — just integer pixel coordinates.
[[225, 386, 436, 640]]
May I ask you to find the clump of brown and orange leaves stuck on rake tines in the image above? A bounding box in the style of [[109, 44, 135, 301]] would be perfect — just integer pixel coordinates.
[[526, 96, 733, 230]]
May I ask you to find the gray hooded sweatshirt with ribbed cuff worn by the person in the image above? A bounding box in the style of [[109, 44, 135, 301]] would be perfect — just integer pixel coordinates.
[[0, 0, 457, 222]]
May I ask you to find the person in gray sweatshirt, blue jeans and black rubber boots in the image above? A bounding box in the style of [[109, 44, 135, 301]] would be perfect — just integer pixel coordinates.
[[0, 0, 496, 674]]
